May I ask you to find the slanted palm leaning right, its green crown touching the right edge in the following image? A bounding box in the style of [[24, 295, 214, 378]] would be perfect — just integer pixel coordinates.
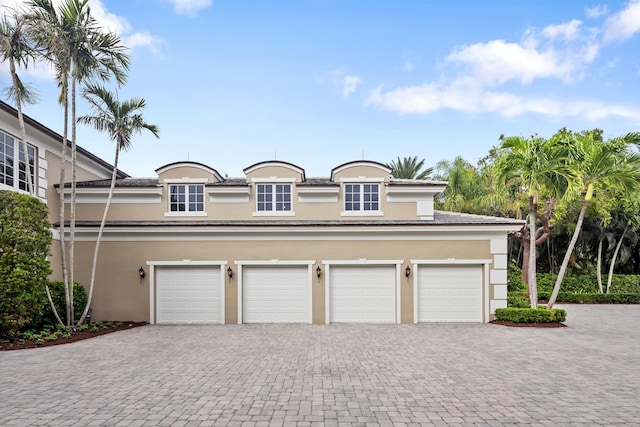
[[547, 129, 640, 308]]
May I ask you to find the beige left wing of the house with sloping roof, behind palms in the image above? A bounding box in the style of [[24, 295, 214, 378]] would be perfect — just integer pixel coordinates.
[[0, 101, 128, 279]]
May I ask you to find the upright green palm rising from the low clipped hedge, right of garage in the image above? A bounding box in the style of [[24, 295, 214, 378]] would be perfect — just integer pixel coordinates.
[[495, 137, 568, 308]]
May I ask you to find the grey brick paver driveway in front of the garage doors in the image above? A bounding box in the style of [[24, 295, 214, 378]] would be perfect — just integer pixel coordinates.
[[0, 306, 640, 426]]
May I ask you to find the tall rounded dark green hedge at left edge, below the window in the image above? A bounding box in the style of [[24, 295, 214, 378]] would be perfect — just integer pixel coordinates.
[[0, 190, 51, 336]]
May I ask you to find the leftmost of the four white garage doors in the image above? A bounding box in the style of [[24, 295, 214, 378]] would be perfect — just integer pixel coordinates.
[[156, 266, 222, 323]]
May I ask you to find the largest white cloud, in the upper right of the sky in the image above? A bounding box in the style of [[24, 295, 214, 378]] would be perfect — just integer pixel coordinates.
[[365, 8, 624, 119]]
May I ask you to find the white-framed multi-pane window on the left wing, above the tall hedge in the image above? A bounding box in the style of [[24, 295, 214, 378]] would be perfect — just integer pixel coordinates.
[[0, 132, 36, 191]]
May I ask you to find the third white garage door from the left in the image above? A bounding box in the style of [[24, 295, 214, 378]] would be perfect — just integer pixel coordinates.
[[329, 266, 396, 323]]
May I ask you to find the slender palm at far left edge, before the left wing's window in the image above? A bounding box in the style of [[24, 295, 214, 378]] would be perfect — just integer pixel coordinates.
[[0, 10, 35, 195]]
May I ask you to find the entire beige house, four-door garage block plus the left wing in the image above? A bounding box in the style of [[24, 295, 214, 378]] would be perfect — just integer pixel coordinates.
[[0, 100, 523, 324]]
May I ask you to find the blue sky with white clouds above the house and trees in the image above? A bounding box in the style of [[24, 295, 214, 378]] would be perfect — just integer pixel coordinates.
[[0, 0, 640, 177]]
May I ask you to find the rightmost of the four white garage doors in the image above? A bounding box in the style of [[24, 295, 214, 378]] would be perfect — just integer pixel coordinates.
[[417, 265, 482, 322]]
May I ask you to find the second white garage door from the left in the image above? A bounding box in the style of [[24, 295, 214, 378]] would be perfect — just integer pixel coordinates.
[[242, 266, 310, 323]]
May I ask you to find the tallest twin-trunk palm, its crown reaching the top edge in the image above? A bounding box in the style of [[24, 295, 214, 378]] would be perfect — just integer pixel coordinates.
[[27, 0, 129, 325]]
